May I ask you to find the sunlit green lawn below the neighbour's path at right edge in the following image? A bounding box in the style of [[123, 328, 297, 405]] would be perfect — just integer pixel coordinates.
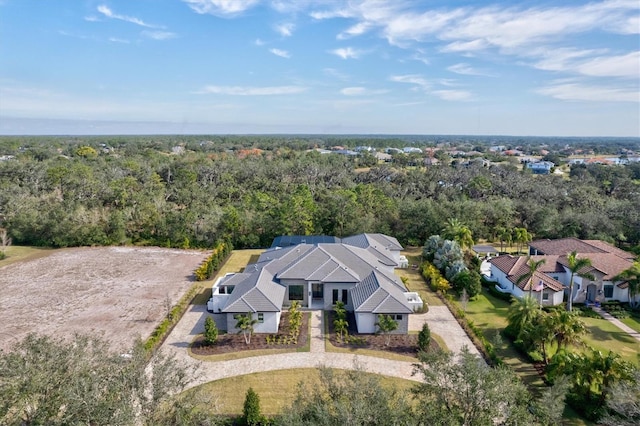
[[583, 318, 640, 364]]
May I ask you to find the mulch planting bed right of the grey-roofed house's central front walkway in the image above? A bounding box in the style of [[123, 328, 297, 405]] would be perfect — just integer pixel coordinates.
[[326, 311, 428, 356]]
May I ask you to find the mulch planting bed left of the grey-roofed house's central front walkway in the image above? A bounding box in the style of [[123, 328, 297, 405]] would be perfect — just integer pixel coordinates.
[[191, 312, 309, 355]]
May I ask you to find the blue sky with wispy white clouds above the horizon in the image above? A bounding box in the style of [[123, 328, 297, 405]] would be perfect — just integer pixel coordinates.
[[0, 0, 640, 137]]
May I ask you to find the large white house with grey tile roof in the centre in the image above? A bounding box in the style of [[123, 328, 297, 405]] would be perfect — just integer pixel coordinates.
[[208, 234, 422, 333]]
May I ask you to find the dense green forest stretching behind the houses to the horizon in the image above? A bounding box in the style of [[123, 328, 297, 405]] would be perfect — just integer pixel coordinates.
[[0, 136, 640, 249]]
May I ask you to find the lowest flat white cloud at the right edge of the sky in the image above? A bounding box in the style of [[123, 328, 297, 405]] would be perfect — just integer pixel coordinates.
[[537, 81, 640, 102]]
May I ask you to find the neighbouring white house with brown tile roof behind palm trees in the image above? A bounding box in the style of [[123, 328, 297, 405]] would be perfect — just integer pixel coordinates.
[[485, 238, 635, 305]]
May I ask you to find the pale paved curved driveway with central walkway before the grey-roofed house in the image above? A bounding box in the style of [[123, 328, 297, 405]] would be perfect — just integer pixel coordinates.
[[162, 305, 478, 387]]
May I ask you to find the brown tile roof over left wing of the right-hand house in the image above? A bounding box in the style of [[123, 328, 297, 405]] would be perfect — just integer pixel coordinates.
[[489, 254, 564, 291]]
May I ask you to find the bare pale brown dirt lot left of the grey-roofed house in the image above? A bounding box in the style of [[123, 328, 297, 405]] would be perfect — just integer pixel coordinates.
[[0, 247, 206, 349]]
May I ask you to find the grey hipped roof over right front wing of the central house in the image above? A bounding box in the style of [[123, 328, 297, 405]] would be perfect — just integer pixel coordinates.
[[351, 271, 413, 314]]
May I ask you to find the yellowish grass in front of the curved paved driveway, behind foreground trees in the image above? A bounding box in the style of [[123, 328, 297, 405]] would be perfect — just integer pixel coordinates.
[[189, 368, 415, 416]]
